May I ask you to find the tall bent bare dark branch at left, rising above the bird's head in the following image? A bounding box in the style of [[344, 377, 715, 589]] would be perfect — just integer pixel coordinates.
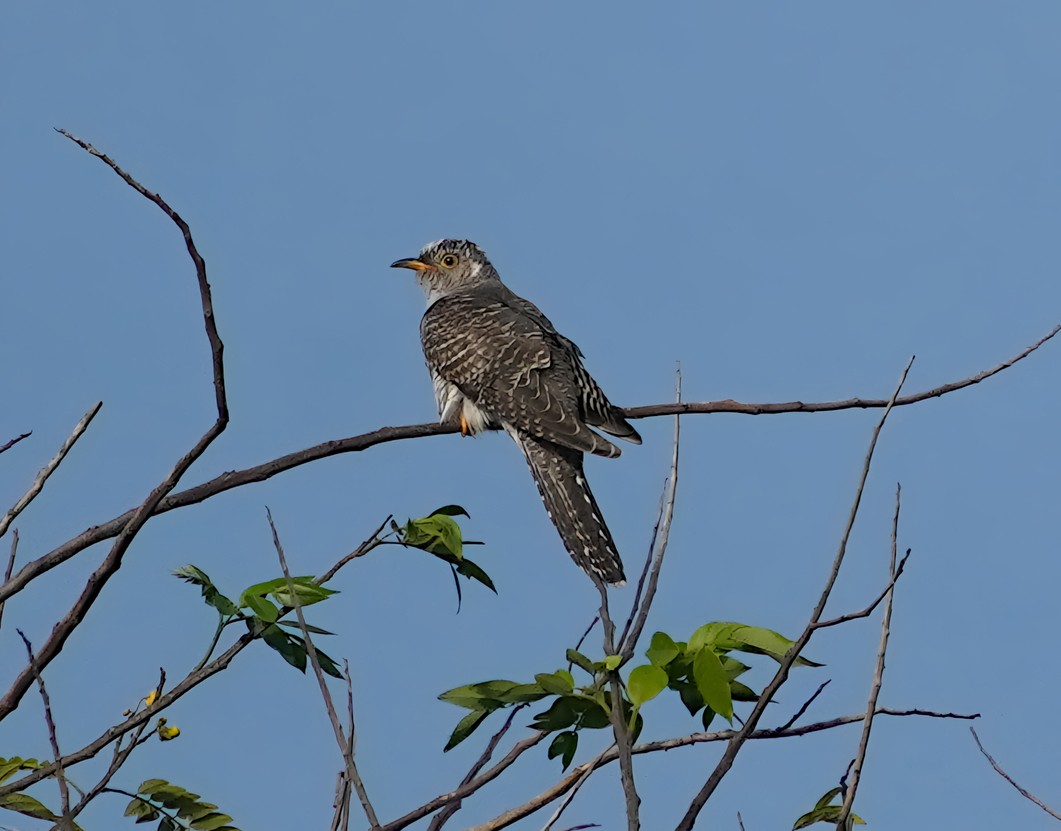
[[0, 131, 228, 720]]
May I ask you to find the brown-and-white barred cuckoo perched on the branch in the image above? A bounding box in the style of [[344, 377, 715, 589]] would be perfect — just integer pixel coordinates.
[[392, 239, 641, 587]]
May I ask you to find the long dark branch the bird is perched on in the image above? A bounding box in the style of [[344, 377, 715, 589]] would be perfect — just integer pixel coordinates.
[[6, 326, 1061, 600]]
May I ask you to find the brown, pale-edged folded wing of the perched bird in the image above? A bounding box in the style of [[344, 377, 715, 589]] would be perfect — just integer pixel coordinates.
[[420, 292, 619, 456]]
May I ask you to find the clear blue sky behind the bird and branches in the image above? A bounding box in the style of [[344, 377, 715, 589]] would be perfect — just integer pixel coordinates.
[[0, 2, 1061, 829]]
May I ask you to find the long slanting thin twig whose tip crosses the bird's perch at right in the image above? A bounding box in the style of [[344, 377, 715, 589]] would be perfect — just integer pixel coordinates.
[[675, 358, 914, 831]]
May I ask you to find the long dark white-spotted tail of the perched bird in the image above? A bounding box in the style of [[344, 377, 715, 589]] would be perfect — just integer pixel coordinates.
[[512, 432, 626, 586]]
